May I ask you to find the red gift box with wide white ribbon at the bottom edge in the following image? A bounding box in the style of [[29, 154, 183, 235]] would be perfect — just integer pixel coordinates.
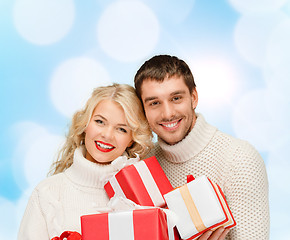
[[81, 208, 179, 240]]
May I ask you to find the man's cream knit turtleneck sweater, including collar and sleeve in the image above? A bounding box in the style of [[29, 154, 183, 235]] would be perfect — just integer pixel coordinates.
[[150, 114, 270, 240]]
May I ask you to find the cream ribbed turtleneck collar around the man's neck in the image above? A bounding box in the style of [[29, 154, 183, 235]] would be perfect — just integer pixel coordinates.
[[158, 113, 217, 163]]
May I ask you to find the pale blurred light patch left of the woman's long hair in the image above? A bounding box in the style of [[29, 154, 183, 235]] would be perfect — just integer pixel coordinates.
[[13, 122, 64, 189]]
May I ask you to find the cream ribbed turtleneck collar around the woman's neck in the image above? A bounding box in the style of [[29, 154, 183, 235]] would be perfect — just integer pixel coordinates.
[[64, 146, 119, 188]]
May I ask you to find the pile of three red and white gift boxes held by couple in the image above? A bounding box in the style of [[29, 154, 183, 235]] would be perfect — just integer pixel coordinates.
[[81, 156, 236, 240]]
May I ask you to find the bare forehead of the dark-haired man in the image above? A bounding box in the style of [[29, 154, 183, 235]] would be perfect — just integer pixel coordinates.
[[141, 76, 190, 101]]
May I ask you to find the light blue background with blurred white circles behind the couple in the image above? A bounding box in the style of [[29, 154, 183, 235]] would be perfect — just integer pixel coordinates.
[[0, 0, 290, 240]]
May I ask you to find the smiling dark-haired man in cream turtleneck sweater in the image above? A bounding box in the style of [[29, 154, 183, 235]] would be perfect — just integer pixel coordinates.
[[134, 55, 269, 240]]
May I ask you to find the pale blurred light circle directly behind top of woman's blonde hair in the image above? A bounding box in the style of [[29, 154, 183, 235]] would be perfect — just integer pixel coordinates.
[[50, 58, 110, 118]]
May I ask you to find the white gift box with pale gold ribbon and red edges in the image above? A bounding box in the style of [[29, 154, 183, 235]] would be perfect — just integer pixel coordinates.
[[164, 176, 236, 239]]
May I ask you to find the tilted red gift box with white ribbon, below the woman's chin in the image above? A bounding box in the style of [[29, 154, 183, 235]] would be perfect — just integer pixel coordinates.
[[104, 156, 173, 207]]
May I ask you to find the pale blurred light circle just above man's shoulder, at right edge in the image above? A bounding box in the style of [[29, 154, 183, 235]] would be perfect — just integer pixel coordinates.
[[233, 90, 289, 151]]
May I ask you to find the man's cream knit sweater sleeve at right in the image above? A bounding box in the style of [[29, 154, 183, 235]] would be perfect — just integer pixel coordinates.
[[225, 142, 270, 240]]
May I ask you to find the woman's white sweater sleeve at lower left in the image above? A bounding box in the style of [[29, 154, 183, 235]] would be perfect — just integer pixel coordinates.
[[17, 189, 49, 240]]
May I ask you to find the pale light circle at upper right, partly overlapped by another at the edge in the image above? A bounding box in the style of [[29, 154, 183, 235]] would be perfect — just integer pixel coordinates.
[[234, 12, 287, 66]]
